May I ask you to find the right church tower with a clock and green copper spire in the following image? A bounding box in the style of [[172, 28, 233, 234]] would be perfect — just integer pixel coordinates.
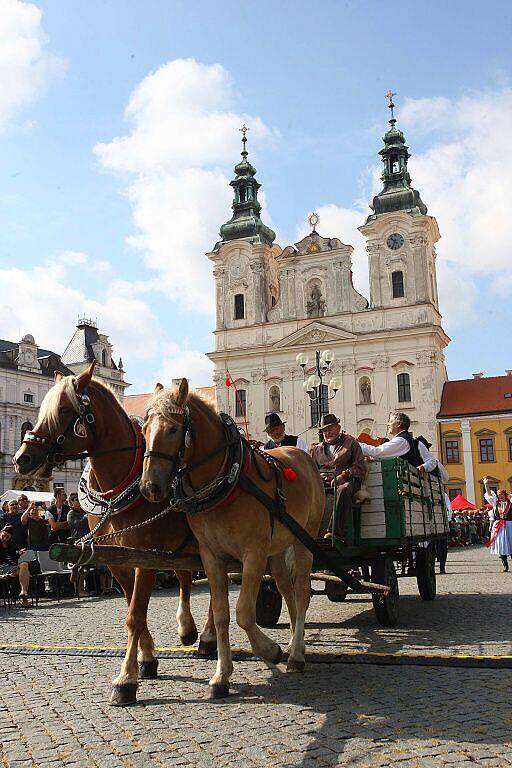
[[359, 92, 440, 312]]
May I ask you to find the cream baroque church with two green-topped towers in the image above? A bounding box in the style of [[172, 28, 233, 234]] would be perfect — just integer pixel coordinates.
[[207, 97, 449, 449]]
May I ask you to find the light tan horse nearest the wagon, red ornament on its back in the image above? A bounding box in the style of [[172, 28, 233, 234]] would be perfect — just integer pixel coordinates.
[[140, 379, 325, 698]]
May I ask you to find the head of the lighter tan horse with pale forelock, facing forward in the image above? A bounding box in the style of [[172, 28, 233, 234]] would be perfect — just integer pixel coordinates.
[[140, 379, 190, 502]]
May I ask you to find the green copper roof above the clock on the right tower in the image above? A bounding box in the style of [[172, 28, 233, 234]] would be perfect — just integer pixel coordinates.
[[369, 98, 427, 218]]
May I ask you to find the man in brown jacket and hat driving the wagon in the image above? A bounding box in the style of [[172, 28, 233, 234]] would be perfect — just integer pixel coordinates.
[[311, 413, 366, 539]]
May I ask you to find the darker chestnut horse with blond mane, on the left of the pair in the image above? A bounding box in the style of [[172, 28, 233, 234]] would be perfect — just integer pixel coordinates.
[[13, 362, 215, 706]]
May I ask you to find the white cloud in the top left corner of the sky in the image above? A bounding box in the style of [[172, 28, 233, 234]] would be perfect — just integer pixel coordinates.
[[0, 0, 65, 131]]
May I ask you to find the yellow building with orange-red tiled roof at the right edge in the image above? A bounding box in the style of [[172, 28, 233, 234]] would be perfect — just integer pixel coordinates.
[[437, 371, 512, 505]]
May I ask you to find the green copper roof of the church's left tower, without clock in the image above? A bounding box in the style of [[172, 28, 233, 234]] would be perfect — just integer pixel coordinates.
[[220, 129, 276, 245]]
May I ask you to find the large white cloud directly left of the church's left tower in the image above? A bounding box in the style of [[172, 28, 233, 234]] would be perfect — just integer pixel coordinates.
[[94, 59, 271, 314]]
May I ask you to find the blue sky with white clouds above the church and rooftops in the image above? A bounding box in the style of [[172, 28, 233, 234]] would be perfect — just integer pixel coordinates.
[[0, 0, 512, 393]]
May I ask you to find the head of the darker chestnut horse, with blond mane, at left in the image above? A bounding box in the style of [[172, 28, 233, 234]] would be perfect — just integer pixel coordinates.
[[13, 362, 95, 478]]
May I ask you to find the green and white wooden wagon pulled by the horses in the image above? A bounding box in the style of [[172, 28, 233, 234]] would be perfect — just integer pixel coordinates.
[[258, 459, 448, 626]]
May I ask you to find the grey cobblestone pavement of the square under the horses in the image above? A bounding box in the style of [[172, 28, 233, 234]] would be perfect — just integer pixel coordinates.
[[0, 548, 512, 768]]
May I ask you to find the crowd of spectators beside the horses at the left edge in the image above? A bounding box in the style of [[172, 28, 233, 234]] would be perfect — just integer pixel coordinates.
[[0, 488, 113, 606]]
